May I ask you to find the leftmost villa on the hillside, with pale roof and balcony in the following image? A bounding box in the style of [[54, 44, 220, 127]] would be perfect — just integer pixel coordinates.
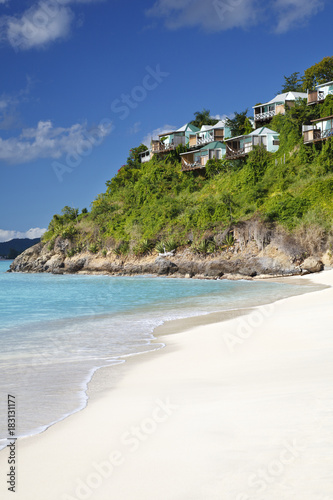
[[140, 123, 200, 163]]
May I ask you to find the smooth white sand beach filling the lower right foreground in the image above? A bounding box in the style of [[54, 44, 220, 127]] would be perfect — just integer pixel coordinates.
[[0, 271, 333, 500]]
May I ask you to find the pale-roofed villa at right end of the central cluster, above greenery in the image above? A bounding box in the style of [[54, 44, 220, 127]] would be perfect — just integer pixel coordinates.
[[225, 127, 280, 160]]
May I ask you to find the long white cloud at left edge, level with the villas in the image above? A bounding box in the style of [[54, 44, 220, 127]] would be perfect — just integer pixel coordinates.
[[0, 120, 112, 163]]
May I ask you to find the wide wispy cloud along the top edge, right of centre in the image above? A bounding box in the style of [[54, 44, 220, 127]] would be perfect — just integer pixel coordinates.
[[146, 0, 325, 33]]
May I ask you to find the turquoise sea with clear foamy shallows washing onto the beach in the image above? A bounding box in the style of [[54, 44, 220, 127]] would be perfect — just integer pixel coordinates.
[[0, 261, 318, 449]]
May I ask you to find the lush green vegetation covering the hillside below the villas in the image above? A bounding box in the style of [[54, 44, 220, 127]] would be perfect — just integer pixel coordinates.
[[43, 61, 333, 256]]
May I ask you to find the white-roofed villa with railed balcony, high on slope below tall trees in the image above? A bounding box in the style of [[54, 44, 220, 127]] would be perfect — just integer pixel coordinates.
[[253, 92, 308, 127]]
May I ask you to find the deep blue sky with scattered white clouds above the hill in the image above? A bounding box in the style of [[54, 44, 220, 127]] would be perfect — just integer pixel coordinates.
[[0, 0, 333, 241]]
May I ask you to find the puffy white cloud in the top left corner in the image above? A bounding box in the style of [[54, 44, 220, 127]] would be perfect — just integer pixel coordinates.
[[0, 0, 102, 50]]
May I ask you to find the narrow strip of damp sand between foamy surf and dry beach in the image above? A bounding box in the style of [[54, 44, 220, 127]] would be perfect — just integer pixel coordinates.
[[0, 271, 333, 499]]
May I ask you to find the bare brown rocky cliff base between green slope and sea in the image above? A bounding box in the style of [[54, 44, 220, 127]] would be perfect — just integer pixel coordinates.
[[10, 238, 324, 279]]
